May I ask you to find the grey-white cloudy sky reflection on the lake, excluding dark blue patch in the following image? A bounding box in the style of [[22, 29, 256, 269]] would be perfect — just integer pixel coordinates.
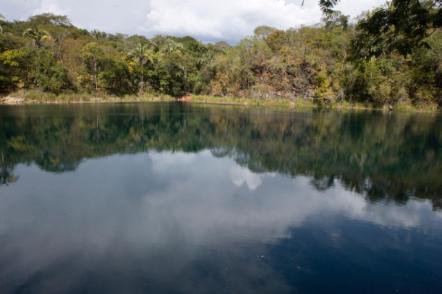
[[0, 151, 442, 293]]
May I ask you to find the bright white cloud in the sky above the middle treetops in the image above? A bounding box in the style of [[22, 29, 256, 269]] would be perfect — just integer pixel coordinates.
[[142, 0, 321, 40]]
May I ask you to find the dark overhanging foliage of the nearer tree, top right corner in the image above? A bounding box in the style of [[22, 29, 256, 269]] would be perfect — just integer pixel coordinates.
[[319, 0, 442, 58]]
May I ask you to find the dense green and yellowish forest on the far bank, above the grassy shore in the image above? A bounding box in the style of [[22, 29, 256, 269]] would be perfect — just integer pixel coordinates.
[[0, 0, 442, 106]]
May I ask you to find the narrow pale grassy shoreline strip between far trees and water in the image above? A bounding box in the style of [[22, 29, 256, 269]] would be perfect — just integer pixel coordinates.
[[0, 93, 441, 113]]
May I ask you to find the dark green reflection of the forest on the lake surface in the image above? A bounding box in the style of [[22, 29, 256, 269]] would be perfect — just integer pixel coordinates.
[[0, 103, 442, 208]]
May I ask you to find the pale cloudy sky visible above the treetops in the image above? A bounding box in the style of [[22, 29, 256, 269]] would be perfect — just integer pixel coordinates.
[[0, 0, 386, 43]]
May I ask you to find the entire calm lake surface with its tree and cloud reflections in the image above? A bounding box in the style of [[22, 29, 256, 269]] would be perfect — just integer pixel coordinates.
[[0, 103, 442, 294]]
